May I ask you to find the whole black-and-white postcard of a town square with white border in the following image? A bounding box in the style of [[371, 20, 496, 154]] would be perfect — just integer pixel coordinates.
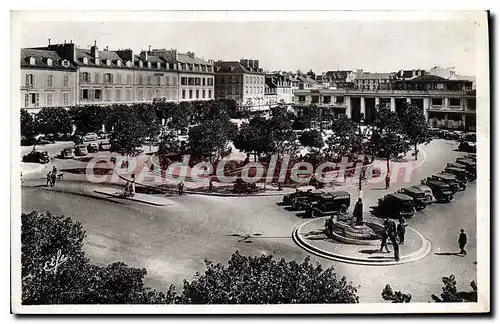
[[11, 11, 490, 314]]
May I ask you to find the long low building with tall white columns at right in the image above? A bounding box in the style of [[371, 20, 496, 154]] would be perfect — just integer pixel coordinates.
[[294, 75, 476, 129]]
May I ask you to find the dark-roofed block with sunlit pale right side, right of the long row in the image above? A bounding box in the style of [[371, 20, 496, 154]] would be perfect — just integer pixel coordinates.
[[214, 59, 266, 109]]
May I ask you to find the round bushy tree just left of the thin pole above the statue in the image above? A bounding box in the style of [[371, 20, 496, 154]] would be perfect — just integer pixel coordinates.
[[326, 116, 362, 158]]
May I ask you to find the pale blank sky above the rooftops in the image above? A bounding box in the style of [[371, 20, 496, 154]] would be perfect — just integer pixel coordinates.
[[22, 21, 475, 75]]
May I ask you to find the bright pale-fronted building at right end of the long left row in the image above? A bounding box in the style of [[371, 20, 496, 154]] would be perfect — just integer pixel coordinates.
[[151, 49, 214, 101]]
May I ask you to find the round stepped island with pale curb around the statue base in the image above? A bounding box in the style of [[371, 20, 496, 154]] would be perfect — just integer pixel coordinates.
[[292, 216, 431, 266]]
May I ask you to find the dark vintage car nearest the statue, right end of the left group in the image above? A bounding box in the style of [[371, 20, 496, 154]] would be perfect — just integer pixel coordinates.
[[305, 191, 351, 217]]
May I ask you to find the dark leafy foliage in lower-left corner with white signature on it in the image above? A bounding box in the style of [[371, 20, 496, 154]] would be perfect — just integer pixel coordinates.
[[21, 211, 174, 305]]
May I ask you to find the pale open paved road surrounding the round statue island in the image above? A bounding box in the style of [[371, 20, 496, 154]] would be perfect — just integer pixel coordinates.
[[22, 141, 476, 302]]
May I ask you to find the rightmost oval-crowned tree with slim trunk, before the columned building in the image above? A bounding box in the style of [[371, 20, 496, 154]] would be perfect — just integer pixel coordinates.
[[401, 103, 432, 160]]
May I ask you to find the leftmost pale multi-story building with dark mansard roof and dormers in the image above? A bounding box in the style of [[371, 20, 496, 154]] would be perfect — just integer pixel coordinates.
[[21, 48, 77, 113]]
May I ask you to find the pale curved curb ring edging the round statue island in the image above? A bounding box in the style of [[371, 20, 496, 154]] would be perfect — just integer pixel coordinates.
[[292, 219, 431, 266]]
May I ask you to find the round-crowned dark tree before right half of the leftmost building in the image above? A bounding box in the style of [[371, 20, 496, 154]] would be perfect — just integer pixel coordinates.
[[36, 107, 71, 135]]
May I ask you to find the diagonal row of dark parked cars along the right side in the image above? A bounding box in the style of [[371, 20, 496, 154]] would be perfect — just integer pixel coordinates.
[[374, 154, 476, 218]]
